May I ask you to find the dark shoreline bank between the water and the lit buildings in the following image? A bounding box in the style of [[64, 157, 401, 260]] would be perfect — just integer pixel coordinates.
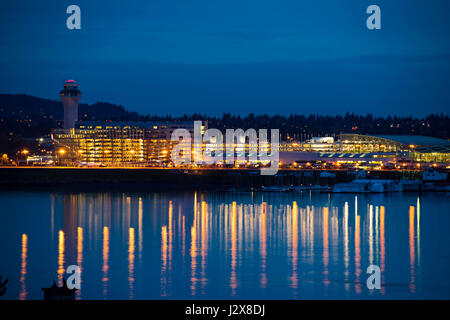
[[0, 167, 428, 191]]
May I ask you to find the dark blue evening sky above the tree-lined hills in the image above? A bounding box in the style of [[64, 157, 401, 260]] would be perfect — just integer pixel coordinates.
[[0, 0, 450, 116]]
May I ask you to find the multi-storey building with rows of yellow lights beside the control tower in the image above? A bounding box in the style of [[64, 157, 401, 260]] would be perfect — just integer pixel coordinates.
[[52, 122, 204, 166]]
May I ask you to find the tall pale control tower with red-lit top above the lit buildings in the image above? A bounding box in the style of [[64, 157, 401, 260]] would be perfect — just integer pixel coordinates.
[[59, 80, 81, 129]]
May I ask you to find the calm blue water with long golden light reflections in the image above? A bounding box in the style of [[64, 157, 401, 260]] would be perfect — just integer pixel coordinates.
[[0, 191, 450, 299]]
